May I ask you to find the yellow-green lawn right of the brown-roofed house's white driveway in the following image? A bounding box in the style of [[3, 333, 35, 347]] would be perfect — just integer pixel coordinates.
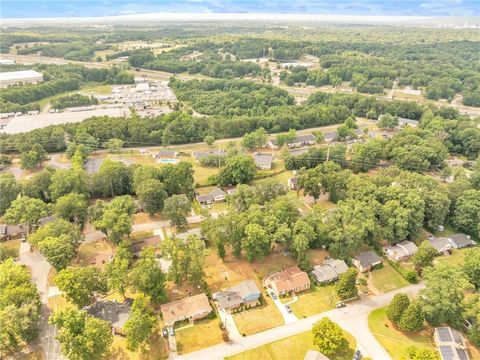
[[290, 285, 339, 318]]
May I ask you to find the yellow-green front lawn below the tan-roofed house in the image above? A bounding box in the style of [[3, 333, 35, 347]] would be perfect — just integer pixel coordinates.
[[175, 318, 223, 354]]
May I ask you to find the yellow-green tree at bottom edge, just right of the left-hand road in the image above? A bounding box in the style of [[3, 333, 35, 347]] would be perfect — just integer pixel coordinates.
[[49, 305, 113, 360]]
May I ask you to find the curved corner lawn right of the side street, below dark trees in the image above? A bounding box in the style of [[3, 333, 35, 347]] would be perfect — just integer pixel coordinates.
[[368, 307, 435, 360]]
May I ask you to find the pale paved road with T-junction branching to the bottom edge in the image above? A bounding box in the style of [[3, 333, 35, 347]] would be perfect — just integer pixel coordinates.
[[174, 284, 423, 360]]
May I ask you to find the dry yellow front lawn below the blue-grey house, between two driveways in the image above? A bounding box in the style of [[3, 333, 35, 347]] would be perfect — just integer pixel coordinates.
[[233, 296, 283, 335]]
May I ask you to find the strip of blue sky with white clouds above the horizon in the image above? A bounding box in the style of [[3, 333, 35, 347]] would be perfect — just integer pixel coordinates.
[[0, 0, 480, 19]]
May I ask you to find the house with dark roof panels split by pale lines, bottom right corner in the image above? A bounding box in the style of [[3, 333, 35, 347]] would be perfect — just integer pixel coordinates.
[[433, 327, 470, 360]]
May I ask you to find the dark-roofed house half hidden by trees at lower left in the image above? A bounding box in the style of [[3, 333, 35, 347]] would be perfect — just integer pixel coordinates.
[[87, 299, 133, 334]]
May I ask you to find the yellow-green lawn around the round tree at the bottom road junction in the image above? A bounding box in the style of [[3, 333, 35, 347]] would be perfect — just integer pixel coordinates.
[[226, 331, 356, 360]]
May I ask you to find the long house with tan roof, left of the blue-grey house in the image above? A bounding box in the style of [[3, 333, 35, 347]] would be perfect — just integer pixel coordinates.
[[160, 293, 212, 326]]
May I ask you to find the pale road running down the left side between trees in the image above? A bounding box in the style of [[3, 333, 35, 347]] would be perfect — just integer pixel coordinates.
[[19, 242, 63, 360]]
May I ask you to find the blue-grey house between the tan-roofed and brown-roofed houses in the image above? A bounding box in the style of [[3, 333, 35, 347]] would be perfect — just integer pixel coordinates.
[[212, 280, 261, 312]]
